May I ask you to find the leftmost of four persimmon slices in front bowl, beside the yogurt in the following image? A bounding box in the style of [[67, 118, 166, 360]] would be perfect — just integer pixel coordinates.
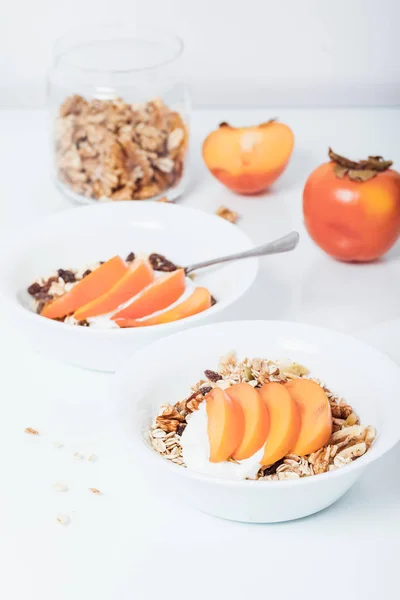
[[205, 388, 244, 463]]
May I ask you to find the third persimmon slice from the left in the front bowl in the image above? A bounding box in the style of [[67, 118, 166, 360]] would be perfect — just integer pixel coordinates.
[[258, 382, 301, 466]]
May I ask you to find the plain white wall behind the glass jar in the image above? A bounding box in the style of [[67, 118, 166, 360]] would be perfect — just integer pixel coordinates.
[[0, 0, 400, 106]]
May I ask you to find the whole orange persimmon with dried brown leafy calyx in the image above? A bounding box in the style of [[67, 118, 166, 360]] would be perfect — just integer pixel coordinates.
[[303, 149, 400, 262]]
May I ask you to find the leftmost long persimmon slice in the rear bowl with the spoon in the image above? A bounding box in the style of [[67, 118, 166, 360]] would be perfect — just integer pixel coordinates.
[[40, 256, 128, 319]]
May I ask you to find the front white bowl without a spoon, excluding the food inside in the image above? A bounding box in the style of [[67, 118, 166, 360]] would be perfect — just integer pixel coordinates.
[[113, 321, 400, 523]]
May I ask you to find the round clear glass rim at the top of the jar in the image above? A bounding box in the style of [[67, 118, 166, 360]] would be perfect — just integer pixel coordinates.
[[53, 22, 184, 75]]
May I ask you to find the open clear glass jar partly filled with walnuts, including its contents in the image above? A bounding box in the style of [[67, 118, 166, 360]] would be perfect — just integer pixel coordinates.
[[48, 25, 189, 203]]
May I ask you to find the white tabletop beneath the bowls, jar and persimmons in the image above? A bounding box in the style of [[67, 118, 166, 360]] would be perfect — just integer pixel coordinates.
[[0, 109, 400, 600]]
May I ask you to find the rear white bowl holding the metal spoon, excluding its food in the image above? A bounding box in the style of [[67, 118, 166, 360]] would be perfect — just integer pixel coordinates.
[[0, 202, 258, 371]]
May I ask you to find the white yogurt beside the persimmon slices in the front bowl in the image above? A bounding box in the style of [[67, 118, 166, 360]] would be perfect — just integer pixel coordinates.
[[181, 402, 264, 481]]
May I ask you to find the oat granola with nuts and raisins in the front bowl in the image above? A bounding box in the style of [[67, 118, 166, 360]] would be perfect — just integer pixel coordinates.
[[149, 352, 376, 481]]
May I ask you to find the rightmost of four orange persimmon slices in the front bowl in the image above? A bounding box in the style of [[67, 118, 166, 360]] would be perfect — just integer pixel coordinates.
[[285, 379, 332, 456]]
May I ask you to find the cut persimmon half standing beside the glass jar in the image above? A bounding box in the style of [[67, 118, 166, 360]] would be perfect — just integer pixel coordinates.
[[203, 119, 294, 194]]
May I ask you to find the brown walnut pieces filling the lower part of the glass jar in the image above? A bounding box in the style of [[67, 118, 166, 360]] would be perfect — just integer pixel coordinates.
[[54, 95, 188, 200]]
